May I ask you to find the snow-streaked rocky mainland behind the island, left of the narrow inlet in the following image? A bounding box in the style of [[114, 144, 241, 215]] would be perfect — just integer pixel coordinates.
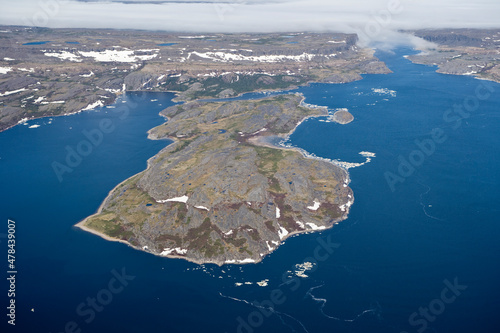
[[0, 26, 389, 131]]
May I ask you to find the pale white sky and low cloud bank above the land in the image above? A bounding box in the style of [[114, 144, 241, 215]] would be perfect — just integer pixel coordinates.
[[0, 0, 500, 45]]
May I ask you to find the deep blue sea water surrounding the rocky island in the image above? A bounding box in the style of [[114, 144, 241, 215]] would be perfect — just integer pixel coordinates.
[[0, 49, 500, 333]]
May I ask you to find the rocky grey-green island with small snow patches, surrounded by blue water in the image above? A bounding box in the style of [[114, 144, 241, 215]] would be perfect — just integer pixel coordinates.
[[84, 95, 353, 264]]
